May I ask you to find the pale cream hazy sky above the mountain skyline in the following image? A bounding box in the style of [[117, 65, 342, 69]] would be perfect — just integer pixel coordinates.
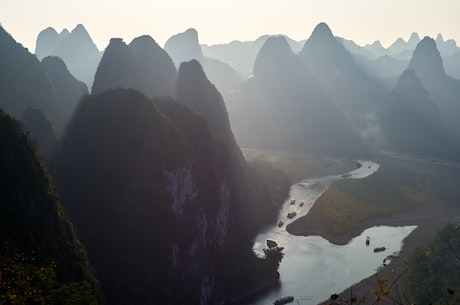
[[0, 0, 460, 52]]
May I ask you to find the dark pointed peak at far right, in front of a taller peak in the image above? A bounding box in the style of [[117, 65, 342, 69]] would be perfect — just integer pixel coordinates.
[[378, 69, 458, 160]]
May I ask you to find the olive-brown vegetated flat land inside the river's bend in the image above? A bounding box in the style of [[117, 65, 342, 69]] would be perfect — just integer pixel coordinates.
[[312, 159, 460, 235]]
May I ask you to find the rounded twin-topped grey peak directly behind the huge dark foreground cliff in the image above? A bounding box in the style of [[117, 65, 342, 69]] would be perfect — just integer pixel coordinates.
[[92, 36, 177, 97]]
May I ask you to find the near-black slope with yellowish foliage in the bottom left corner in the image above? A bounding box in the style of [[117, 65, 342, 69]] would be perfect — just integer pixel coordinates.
[[0, 111, 98, 304]]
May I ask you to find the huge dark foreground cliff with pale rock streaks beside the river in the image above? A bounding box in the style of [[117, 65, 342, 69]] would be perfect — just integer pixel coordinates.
[[55, 89, 274, 304]]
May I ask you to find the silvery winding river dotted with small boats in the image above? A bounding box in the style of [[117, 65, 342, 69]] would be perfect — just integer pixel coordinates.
[[253, 161, 415, 305]]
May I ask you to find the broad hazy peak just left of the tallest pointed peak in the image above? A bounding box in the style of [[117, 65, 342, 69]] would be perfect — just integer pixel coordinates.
[[227, 37, 362, 154]]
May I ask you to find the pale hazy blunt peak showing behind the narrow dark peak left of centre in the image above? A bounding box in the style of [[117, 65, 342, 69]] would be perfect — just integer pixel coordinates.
[[164, 28, 243, 94]]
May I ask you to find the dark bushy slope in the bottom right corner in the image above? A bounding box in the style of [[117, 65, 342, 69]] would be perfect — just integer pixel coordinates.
[[408, 224, 460, 305]]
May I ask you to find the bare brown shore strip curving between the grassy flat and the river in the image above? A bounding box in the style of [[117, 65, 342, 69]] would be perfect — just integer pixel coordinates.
[[287, 194, 460, 305]]
